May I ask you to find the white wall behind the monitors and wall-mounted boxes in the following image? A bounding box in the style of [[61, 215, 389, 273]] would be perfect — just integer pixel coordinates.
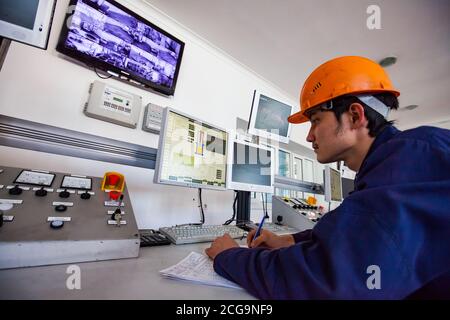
[[0, 0, 308, 228]]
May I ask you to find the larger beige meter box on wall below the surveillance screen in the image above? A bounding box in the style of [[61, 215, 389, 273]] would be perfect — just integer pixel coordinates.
[[84, 81, 142, 128]]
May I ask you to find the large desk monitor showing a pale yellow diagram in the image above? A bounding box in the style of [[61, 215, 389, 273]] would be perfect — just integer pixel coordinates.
[[154, 108, 228, 190]]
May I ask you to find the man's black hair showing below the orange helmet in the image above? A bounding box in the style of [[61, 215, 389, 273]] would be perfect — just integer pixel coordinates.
[[329, 92, 399, 137]]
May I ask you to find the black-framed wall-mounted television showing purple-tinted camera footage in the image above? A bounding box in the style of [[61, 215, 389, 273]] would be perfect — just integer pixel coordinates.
[[56, 0, 184, 95]]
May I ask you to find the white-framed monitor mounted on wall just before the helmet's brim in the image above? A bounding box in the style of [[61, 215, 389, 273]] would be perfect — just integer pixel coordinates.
[[248, 90, 293, 143]]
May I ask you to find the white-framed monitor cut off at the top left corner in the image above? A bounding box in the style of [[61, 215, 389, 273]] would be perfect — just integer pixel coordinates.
[[0, 0, 56, 50]]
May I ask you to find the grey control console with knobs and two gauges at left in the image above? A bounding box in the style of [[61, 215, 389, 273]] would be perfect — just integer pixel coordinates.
[[0, 166, 140, 269]]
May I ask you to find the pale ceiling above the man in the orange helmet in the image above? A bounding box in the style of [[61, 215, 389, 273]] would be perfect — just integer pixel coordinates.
[[144, 0, 450, 129]]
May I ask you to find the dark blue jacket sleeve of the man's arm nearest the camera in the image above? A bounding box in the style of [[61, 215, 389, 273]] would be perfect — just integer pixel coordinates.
[[214, 205, 407, 299]]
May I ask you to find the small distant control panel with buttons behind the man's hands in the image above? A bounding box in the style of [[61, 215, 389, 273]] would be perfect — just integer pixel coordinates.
[[272, 196, 323, 231]]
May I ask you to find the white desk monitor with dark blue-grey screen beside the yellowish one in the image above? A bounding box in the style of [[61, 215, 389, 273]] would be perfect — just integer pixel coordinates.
[[227, 139, 275, 193]]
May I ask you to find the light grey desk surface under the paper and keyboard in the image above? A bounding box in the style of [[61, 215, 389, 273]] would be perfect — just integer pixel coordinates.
[[0, 243, 255, 300]]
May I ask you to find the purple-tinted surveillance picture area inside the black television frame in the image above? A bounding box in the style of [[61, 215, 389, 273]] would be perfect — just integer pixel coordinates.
[[59, 0, 181, 88]]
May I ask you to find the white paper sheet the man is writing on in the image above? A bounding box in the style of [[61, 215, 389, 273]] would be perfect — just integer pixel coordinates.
[[160, 252, 241, 289]]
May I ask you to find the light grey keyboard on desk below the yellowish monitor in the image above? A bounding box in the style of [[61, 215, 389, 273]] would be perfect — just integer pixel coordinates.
[[159, 225, 246, 244]]
